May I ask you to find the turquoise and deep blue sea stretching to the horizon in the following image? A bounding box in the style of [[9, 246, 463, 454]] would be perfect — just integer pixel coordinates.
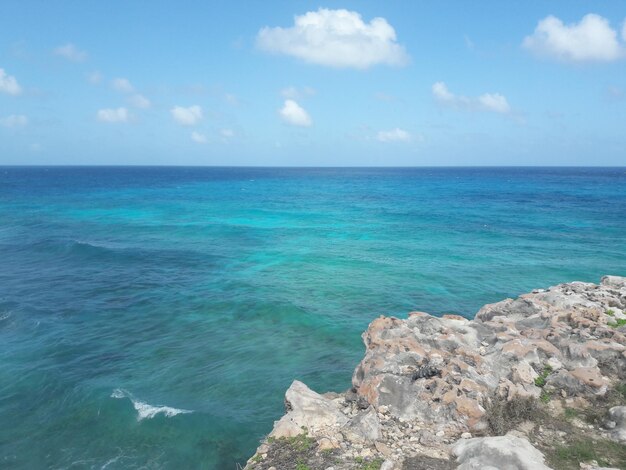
[[0, 167, 626, 469]]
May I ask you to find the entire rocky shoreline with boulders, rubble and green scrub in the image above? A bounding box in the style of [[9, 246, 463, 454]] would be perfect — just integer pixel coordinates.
[[246, 276, 626, 470]]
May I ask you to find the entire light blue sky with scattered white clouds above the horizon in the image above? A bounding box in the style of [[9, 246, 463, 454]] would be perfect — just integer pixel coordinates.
[[0, 0, 626, 166]]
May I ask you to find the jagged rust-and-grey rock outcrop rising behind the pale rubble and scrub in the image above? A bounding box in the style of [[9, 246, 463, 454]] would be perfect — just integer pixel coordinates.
[[352, 276, 626, 434]]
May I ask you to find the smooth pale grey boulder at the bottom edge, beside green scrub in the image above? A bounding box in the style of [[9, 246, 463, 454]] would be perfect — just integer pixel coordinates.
[[452, 435, 550, 470]]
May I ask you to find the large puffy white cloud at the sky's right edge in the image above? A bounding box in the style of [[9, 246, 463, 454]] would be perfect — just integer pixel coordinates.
[[522, 13, 626, 62]]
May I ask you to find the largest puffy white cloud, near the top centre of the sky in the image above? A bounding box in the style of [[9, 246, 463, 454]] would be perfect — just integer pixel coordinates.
[[256, 8, 409, 69]]
